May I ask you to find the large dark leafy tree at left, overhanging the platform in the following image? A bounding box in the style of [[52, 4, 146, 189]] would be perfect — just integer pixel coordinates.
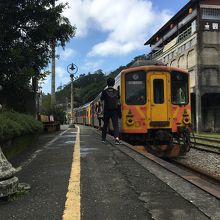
[[0, 0, 76, 111]]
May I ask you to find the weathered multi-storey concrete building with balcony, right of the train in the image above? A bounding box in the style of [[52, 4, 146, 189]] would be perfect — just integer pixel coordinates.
[[145, 0, 220, 132]]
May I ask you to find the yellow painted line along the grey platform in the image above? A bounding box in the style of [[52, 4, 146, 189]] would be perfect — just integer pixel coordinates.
[[63, 126, 81, 220]]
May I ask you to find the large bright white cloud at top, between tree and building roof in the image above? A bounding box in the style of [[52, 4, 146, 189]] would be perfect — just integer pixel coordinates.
[[60, 0, 172, 56]]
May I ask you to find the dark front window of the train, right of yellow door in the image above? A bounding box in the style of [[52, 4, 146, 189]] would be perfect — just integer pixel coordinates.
[[171, 71, 189, 105]]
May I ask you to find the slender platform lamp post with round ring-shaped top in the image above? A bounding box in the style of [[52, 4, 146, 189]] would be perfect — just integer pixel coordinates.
[[67, 63, 78, 128]]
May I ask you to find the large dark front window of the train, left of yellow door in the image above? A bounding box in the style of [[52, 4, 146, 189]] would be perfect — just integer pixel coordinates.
[[125, 71, 146, 105]]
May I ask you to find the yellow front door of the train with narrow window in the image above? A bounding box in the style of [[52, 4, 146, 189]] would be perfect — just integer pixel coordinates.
[[148, 73, 169, 123]]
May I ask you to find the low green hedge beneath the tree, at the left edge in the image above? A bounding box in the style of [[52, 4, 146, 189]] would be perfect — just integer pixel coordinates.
[[0, 112, 43, 141]]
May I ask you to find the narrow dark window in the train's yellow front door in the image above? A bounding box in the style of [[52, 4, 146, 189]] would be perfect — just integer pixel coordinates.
[[153, 79, 164, 104]]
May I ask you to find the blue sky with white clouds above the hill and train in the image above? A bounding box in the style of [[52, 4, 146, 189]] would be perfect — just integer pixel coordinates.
[[42, 0, 189, 93]]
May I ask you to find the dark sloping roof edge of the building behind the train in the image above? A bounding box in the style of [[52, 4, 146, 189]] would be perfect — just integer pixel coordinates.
[[144, 0, 200, 45]]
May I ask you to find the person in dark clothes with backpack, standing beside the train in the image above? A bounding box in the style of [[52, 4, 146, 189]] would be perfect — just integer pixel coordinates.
[[100, 78, 120, 144]]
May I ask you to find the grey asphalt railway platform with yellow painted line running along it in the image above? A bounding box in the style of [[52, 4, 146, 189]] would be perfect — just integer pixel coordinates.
[[0, 125, 220, 220]]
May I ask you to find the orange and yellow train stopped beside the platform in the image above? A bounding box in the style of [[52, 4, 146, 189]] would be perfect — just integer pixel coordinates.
[[74, 60, 192, 158]]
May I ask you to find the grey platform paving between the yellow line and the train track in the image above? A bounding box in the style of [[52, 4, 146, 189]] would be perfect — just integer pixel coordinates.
[[80, 126, 220, 219]]
